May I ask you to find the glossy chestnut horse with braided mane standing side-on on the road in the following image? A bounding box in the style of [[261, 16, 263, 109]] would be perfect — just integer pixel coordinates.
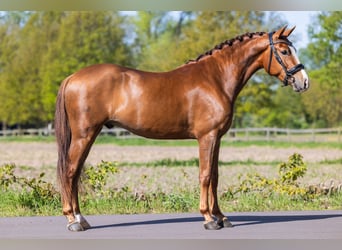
[[54, 25, 309, 231]]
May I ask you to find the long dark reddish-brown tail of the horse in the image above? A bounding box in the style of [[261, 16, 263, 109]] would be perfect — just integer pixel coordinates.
[[54, 77, 71, 196]]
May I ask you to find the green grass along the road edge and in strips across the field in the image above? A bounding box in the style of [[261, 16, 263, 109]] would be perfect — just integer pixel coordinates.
[[0, 136, 342, 217]]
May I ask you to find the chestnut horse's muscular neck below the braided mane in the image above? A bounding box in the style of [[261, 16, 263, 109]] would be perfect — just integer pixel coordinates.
[[212, 37, 268, 101]]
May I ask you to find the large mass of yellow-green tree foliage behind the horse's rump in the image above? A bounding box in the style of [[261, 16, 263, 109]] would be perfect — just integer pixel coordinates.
[[0, 11, 134, 126]]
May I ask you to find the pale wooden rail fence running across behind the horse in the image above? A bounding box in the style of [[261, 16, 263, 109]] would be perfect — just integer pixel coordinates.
[[0, 127, 342, 142]]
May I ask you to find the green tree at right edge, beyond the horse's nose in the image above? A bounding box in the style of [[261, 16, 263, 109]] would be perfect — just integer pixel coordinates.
[[303, 11, 342, 127]]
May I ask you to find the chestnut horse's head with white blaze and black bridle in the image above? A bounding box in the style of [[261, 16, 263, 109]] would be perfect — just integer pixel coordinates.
[[264, 26, 309, 92]]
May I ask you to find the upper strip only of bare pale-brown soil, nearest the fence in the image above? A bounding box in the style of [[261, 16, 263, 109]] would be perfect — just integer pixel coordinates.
[[0, 142, 342, 167]]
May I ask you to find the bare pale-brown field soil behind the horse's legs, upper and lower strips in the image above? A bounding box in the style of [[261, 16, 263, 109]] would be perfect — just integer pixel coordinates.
[[0, 142, 342, 193]]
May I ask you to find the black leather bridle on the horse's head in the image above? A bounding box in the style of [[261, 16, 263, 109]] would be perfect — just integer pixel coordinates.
[[267, 32, 304, 86]]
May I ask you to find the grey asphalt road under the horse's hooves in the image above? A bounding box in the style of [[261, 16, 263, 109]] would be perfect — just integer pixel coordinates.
[[0, 210, 342, 239]]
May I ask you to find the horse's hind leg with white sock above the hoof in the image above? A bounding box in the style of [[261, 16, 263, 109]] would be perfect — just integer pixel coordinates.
[[62, 127, 101, 231]]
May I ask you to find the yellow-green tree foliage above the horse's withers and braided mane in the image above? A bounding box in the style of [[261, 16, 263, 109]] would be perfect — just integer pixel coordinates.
[[136, 11, 265, 71]]
